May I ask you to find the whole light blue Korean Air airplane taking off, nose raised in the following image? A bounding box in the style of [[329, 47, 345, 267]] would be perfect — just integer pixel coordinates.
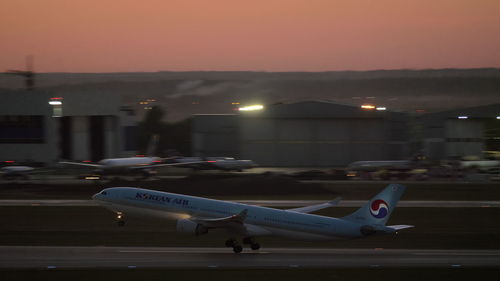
[[92, 184, 413, 253]]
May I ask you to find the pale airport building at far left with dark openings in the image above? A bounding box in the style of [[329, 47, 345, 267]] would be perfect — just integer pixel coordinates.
[[0, 90, 137, 163]]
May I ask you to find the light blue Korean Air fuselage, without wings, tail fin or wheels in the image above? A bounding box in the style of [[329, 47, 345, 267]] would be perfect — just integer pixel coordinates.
[[93, 187, 364, 240]]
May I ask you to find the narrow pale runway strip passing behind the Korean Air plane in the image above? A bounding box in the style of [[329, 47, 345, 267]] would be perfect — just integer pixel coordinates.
[[0, 199, 500, 208]]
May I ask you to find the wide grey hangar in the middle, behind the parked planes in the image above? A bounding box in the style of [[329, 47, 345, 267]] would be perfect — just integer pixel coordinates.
[[192, 101, 411, 167]]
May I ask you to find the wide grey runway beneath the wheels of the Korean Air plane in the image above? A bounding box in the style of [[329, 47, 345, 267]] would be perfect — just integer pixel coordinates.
[[0, 246, 500, 269]]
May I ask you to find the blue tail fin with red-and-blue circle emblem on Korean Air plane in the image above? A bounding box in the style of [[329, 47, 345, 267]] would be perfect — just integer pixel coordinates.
[[343, 184, 406, 225]]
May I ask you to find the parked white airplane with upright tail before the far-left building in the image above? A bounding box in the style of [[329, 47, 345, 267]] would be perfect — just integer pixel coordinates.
[[59, 135, 205, 178]]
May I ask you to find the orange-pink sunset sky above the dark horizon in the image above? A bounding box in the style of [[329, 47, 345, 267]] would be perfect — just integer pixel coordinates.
[[0, 0, 500, 72]]
